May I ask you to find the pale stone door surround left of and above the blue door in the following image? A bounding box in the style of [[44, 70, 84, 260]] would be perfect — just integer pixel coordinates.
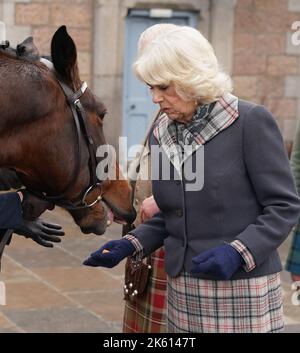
[[93, 0, 210, 148]]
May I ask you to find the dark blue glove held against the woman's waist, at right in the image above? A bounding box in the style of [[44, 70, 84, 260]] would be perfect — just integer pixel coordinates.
[[191, 244, 245, 280]]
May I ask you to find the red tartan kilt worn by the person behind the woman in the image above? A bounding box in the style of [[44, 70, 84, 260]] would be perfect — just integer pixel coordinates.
[[123, 248, 167, 333]]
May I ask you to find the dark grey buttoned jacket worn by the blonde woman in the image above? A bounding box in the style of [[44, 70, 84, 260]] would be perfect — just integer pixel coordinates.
[[130, 100, 300, 279]]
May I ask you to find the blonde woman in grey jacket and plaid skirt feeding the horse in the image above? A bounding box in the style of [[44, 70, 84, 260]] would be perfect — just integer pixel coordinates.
[[84, 26, 300, 332]]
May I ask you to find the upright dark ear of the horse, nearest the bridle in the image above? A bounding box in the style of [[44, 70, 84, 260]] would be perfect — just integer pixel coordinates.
[[51, 26, 79, 85]]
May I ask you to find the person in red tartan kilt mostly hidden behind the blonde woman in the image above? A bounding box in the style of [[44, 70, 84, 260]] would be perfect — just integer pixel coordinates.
[[123, 160, 166, 333]]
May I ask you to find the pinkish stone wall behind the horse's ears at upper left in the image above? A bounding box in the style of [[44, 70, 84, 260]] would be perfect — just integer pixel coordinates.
[[0, 0, 94, 84]]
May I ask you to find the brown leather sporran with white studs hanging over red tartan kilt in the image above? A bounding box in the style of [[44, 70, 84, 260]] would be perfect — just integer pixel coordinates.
[[124, 256, 152, 301]]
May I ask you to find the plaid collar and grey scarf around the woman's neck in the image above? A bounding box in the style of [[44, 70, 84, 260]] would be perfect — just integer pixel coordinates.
[[153, 93, 239, 175]]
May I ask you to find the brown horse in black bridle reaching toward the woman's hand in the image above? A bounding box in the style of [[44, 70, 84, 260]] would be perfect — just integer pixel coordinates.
[[0, 26, 135, 235]]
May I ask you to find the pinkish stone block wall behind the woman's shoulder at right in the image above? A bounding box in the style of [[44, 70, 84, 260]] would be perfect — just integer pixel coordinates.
[[233, 0, 300, 144]]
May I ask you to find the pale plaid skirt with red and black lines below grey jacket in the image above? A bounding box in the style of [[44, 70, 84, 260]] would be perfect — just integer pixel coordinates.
[[168, 272, 284, 333]]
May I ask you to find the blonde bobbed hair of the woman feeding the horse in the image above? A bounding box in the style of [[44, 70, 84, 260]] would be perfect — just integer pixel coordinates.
[[133, 24, 232, 104]]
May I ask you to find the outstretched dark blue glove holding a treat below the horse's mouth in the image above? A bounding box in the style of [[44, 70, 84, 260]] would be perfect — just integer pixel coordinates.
[[83, 239, 135, 268]]
